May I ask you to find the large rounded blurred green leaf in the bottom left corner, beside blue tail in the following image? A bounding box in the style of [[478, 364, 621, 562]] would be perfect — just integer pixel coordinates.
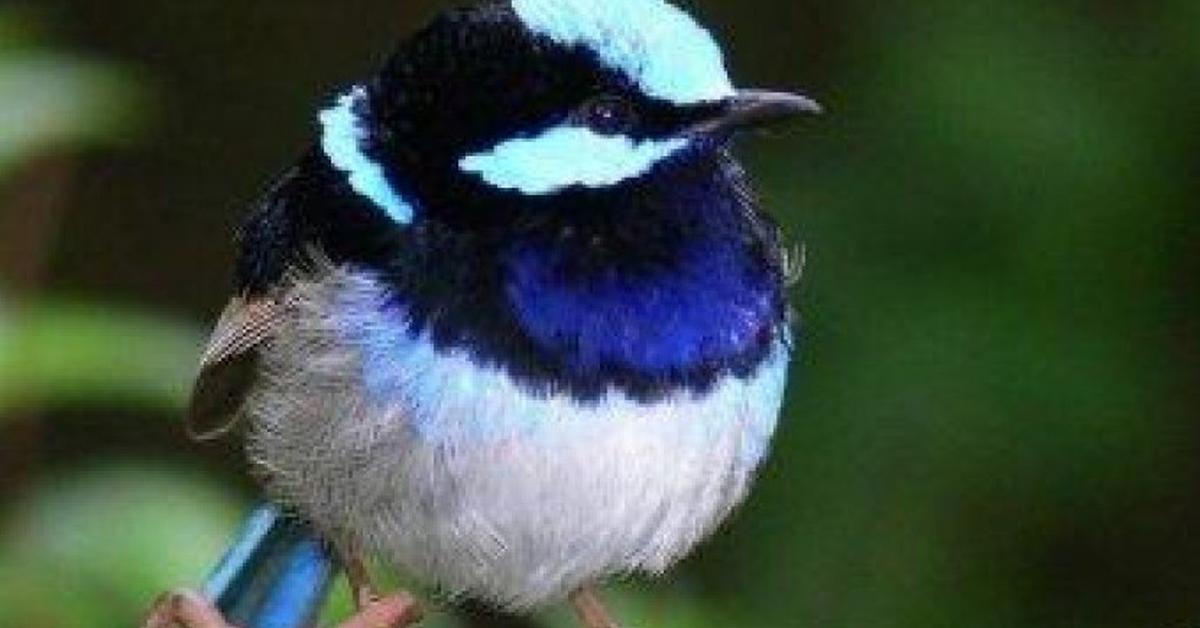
[[0, 461, 246, 627]]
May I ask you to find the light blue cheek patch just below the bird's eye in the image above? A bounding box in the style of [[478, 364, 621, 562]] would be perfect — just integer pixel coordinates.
[[458, 126, 688, 195]]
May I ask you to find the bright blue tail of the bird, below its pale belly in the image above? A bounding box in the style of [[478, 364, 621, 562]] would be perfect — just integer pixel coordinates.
[[204, 506, 337, 628]]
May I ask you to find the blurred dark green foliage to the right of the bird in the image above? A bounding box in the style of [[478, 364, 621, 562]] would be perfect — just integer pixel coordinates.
[[718, 1, 1200, 627]]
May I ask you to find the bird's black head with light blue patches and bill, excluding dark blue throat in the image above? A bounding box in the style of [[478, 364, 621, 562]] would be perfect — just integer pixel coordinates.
[[320, 0, 818, 235]]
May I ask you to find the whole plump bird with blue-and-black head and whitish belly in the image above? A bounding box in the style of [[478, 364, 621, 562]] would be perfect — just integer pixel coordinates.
[[138, 0, 821, 628]]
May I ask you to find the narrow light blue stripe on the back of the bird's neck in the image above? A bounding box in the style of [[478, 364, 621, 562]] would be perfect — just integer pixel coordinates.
[[319, 86, 413, 225]]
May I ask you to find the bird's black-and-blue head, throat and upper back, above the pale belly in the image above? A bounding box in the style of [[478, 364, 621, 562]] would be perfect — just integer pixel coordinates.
[[239, 0, 818, 399]]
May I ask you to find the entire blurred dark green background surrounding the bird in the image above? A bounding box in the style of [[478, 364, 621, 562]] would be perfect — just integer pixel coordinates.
[[0, 0, 1200, 628]]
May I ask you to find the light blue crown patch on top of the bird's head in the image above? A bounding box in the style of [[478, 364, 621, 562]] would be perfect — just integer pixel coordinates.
[[512, 0, 734, 104]]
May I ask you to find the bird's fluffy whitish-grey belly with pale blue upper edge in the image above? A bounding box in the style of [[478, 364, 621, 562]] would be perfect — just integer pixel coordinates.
[[247, 268, 788, 609]]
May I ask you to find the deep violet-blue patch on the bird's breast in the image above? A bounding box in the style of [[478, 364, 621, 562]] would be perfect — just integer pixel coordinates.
[[506, 231, 779, 377]]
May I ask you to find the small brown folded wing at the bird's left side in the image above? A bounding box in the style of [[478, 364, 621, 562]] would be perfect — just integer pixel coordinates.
[[186, 297, 283, 441]]
